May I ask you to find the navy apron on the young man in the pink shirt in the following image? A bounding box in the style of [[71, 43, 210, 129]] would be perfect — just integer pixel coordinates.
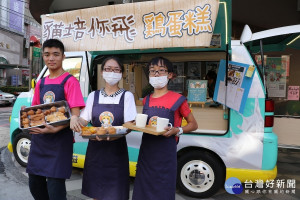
[[26, 74, 73, 179]]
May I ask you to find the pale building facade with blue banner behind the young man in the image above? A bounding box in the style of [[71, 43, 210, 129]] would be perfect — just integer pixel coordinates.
[[0, 0, 41, 86]]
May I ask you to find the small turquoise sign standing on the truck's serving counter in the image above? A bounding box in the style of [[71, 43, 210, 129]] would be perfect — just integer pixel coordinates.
[[188, 80, 207, 102]]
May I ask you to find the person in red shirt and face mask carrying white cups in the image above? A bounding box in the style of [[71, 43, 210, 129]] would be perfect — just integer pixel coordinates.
[[132, 57, 198, 200]]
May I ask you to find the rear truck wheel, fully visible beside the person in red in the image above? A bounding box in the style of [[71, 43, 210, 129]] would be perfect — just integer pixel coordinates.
[[177, 151, 225, 198]]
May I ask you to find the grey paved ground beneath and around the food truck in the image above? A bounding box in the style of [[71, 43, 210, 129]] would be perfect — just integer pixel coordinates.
[[0, 107, 300, 200]]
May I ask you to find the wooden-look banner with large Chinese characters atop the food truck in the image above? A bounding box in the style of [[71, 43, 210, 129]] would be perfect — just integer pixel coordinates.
[[42, 0, 219, 51]]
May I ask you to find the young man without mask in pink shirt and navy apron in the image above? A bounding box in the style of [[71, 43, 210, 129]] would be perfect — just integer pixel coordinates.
[[26, 39, 85, 200]]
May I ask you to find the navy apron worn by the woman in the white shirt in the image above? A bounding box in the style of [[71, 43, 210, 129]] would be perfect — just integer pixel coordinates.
[[82, 90, 129, 200]]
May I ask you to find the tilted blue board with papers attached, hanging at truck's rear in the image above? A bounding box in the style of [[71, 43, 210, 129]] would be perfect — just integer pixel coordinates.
[[213, 60, 255, 113]]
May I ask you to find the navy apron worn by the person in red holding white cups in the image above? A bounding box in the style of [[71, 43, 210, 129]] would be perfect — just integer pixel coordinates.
[[132, 95, 185, 200]]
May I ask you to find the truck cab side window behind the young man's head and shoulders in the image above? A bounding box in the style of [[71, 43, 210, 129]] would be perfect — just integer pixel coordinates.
[[44, 57, 83, 81]]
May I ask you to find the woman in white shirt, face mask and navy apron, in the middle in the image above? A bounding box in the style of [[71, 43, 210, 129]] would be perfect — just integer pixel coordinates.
[[71, 57, 136, 200]]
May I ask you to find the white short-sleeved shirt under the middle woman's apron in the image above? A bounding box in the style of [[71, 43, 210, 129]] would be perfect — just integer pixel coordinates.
[[80, 91, 137, 122]]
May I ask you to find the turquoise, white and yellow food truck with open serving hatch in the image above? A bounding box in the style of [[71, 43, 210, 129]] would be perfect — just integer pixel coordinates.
[[8, 0, 277, 198]]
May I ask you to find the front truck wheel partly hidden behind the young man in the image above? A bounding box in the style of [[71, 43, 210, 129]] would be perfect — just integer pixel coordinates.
[[13, 133, 31, 167]]
